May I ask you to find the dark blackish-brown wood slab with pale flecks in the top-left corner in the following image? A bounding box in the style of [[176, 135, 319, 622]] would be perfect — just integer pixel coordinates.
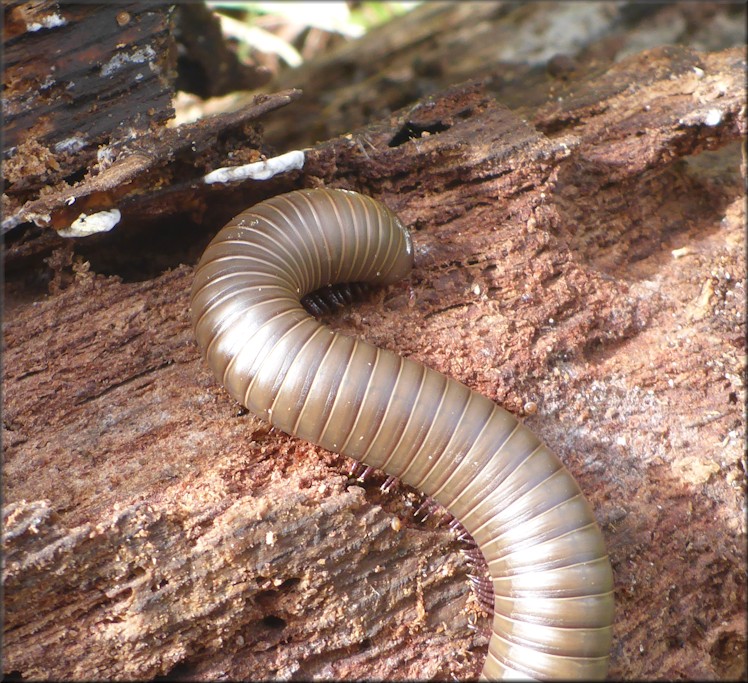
[[3, 1, 176, 206]]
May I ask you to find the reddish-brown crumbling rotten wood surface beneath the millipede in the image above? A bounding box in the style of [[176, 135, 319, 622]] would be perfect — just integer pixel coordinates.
[[3, 1, 746, 680]]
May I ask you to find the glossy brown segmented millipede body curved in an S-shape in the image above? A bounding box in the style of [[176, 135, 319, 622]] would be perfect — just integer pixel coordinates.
[[192, 189, 613, 680]]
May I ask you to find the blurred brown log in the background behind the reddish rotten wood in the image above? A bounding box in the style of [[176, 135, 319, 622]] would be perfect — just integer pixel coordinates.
[[254, 1, 746, 148]]
